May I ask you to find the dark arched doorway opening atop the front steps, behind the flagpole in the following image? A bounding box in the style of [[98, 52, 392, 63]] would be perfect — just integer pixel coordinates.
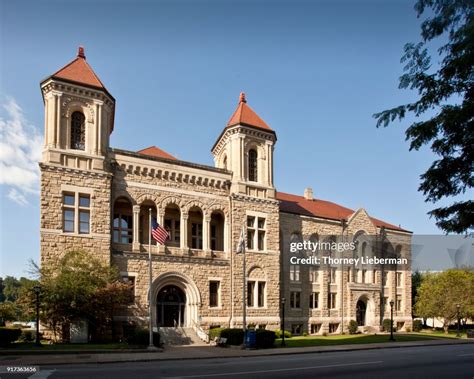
[[156, 285, 186, 327]]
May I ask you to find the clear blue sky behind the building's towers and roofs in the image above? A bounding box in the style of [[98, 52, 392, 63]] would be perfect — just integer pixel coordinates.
[[0, 0, 454, 275]]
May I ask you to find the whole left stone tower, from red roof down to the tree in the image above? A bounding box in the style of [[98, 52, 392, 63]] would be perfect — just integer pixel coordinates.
[[39, 47, 115, 264]]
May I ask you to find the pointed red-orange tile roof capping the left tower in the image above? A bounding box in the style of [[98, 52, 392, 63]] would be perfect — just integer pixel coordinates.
[[52, 46, 106, 90]]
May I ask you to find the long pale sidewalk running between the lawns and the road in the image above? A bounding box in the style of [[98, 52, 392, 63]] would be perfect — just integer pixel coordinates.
[[0, 339, 474, 366]]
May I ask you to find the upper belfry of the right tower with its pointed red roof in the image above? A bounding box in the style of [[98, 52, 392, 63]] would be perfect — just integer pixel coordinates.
[[211, 92, 277, 199]]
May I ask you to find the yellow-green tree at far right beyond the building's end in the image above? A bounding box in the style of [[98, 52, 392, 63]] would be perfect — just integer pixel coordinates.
[[415, 269, 474, 333]]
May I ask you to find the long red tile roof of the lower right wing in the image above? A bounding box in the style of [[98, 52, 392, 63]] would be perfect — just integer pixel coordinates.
[[276, 192, 406, 231]]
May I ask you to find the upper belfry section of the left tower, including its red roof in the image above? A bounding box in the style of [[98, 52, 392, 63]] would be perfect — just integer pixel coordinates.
[[41, 47, 115, 170]]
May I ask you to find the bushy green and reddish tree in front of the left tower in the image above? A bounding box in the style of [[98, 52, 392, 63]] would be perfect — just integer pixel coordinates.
[[26, 251, 130, 339]]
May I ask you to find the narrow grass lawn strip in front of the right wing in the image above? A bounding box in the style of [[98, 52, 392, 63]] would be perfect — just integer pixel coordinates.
[[275, 333, 456, 347]]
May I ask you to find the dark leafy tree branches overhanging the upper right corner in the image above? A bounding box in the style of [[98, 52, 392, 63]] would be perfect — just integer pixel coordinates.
[[374, 0, 474, 233]]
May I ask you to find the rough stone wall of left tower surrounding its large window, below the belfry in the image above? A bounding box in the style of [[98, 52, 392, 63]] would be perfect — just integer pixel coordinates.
[[40, 164, 111, 265]]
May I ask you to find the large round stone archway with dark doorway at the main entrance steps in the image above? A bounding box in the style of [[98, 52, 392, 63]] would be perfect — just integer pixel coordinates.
[[151, 272, 201, 327]]
